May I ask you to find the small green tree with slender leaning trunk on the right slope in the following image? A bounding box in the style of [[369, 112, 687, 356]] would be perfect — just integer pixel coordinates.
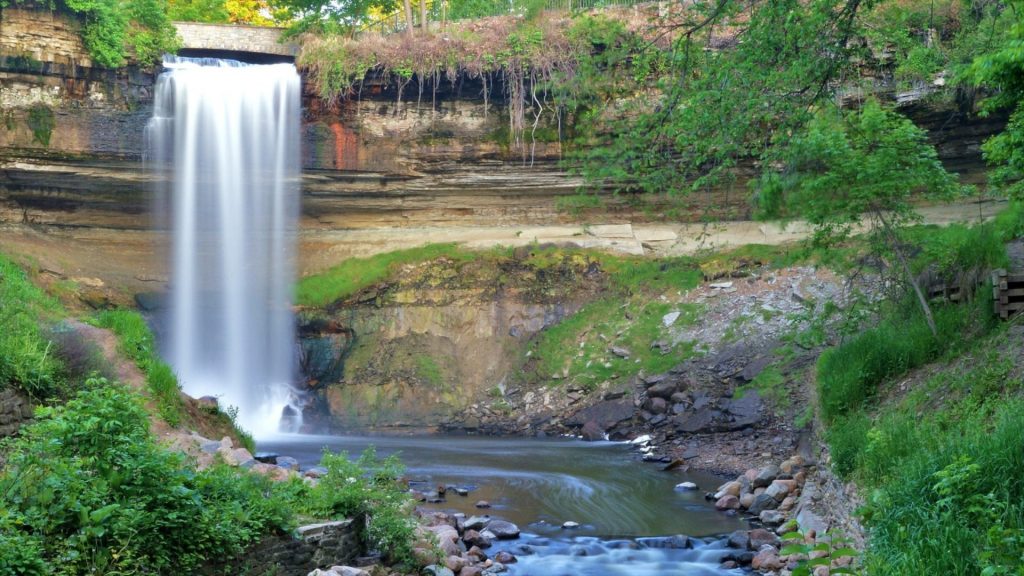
[[757, 100, 963, 335]]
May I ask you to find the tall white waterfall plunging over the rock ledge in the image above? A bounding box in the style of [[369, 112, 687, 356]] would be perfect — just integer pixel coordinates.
[[147, 56, 300, 437]]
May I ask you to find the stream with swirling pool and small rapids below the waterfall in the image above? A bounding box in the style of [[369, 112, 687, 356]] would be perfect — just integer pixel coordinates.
[[259, 435, 746, 576]]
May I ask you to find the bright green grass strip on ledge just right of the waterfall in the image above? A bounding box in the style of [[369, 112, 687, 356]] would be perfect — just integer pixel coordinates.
[[296, 244, 475, 306]]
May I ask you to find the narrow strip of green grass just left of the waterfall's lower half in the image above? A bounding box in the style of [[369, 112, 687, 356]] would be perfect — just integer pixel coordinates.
[[96, 310, 182, 426]]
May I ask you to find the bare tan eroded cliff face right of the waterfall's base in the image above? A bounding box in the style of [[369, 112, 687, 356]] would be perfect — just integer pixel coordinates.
[[300, 248, 604, 431]]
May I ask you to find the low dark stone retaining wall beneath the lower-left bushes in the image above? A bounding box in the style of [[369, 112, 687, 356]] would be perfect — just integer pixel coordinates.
[[239, 520, 364, 576]]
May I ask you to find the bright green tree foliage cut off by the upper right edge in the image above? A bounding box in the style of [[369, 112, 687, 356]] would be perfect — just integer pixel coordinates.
[[971, 0, 1024, 199]]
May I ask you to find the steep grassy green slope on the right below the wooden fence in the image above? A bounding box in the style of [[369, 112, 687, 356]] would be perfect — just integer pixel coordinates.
[[817, 200, 1024, 576]]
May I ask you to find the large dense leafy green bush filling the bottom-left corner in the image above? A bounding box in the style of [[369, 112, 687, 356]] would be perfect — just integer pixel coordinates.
[[0, 379, 292, 575]]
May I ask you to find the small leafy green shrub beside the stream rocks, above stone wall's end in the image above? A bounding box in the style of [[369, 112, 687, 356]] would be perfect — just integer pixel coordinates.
[[303, 447, 416, 568]]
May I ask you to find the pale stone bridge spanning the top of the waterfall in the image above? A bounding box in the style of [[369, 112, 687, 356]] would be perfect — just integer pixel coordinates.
[[174, 22, 299, 64]]
